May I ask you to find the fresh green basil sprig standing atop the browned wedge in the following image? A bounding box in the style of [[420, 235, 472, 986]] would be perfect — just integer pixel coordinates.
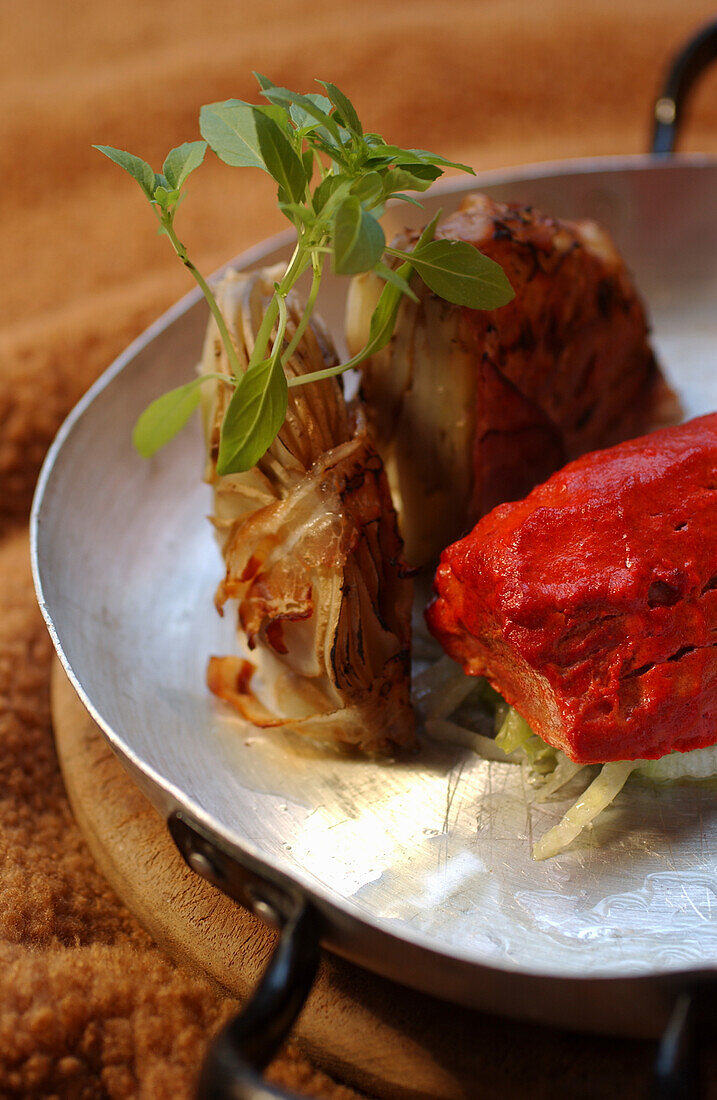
[[95, 74, 514, 474]]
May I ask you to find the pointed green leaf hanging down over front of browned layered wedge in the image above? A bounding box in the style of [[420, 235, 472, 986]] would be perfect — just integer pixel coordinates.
[[217, 352, 288, 475]]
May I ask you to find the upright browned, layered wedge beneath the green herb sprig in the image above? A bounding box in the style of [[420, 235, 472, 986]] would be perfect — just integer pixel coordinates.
[[201, 268, 413, 752]]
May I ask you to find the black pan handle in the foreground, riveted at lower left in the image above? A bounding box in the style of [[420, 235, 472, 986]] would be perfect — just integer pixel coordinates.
[[167, 813, 321, 1100]]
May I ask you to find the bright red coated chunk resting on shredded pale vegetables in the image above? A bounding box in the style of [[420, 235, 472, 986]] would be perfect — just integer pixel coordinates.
[[427, 414, 717, 763]]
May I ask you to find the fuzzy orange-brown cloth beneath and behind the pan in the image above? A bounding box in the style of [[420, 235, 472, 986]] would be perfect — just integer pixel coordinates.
[[0, 0, 717, 1100]]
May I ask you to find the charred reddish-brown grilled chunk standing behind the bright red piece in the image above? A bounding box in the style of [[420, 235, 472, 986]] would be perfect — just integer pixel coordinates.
[[348, 195, 666, 565]]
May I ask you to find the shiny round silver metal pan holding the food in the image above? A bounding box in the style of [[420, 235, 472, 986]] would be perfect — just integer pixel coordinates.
[[33, 157, 717, 1033]]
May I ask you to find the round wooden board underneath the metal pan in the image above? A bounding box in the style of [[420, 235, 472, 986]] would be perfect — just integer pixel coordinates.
[[52, 662, 668, 1100]]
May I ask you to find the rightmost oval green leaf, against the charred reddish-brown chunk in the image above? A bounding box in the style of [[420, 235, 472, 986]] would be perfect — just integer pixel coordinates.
[[410, 240, 515, 309]]
